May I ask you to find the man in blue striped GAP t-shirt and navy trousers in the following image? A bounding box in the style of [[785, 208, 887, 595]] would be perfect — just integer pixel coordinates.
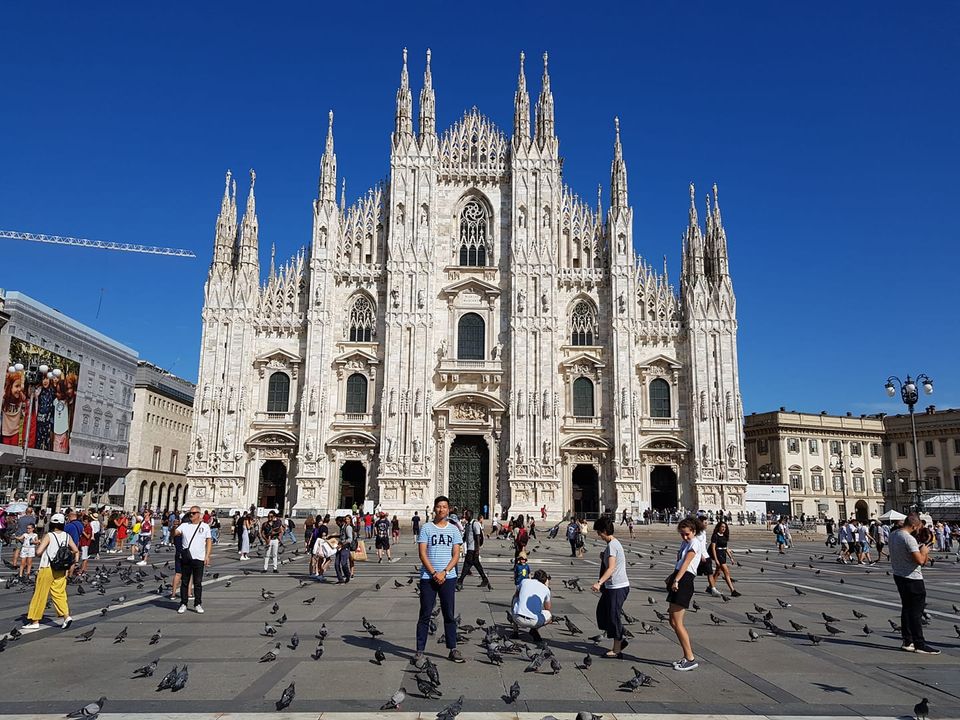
[[413, 495, 464, 667]]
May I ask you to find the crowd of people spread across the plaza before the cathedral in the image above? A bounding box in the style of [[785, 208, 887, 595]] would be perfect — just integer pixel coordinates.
[[0, 496, 960, 671]]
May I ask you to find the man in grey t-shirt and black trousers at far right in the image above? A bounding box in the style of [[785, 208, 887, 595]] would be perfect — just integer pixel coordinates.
[[887, 513, 940, 655]]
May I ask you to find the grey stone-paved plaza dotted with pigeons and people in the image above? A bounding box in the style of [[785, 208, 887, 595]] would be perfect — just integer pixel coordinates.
[[0, 526, 960, 720]]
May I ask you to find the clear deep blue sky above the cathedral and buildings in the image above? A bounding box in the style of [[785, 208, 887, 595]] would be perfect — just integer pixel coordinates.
[[0, 2, 960, 413]]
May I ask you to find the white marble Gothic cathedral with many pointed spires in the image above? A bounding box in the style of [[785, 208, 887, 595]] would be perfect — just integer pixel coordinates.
[[188, 51, 746, 517]]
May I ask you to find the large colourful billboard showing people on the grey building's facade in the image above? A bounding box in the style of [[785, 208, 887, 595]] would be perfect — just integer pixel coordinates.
[[0, 338, 80, 453]]
